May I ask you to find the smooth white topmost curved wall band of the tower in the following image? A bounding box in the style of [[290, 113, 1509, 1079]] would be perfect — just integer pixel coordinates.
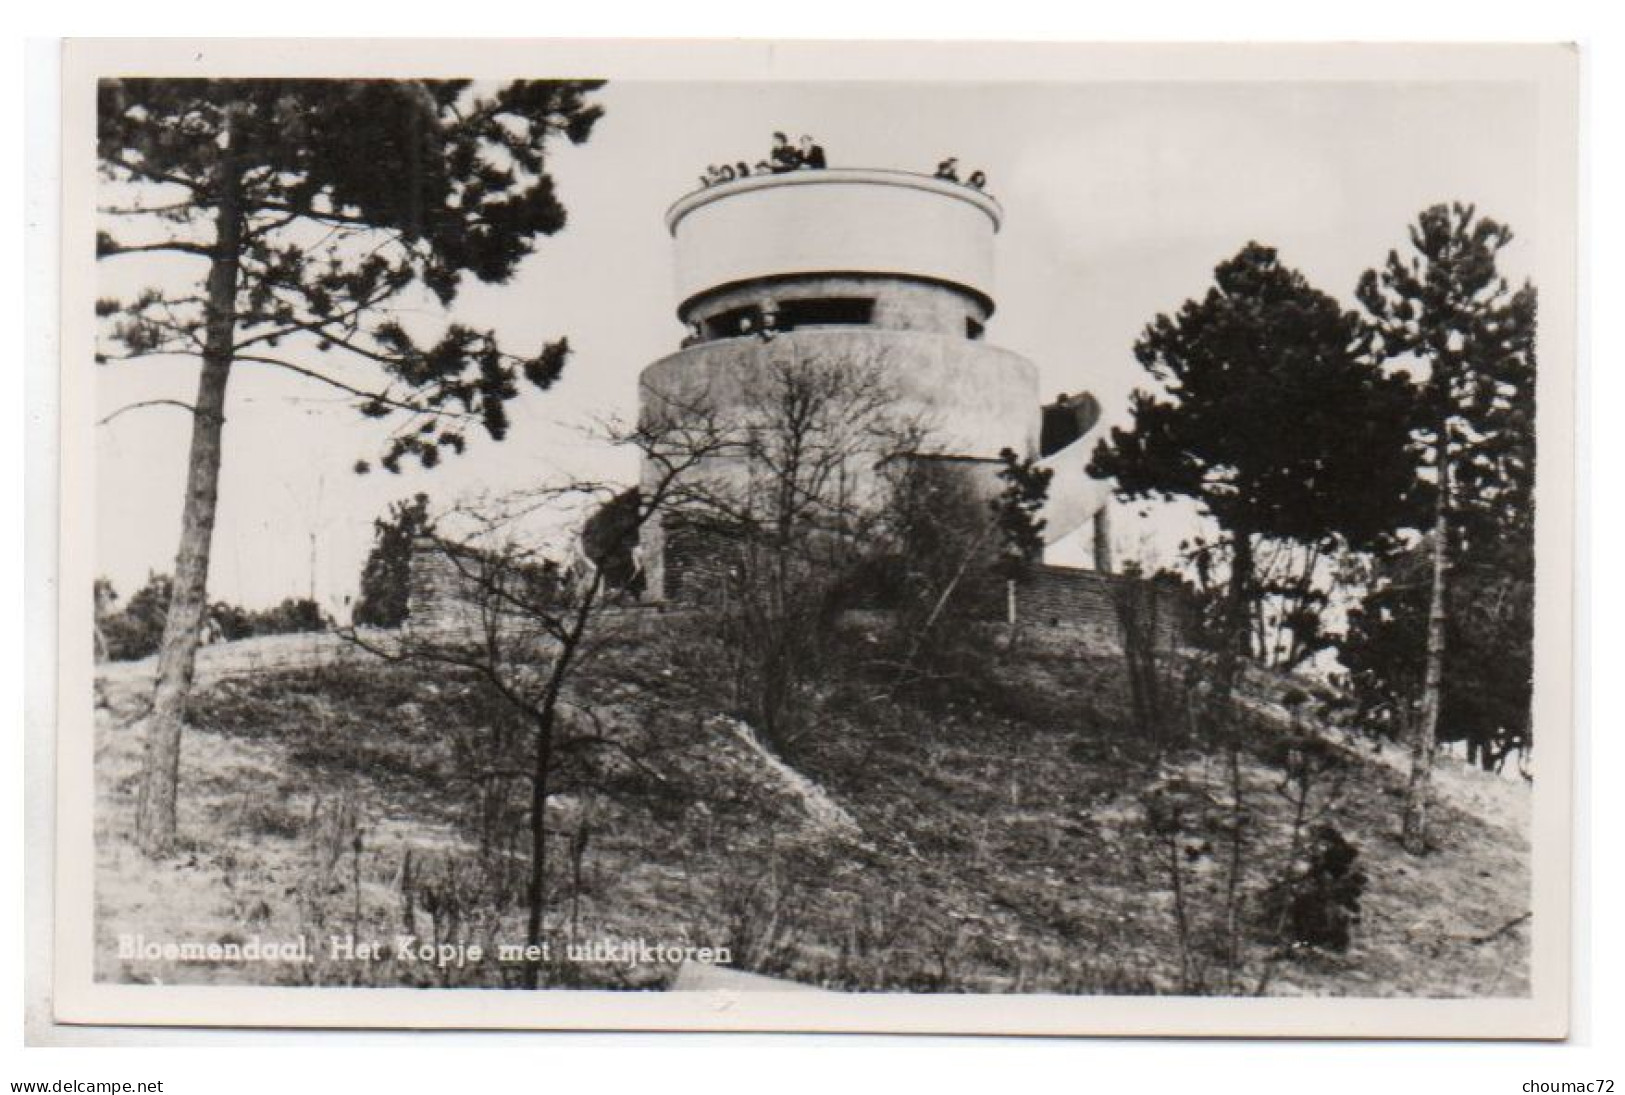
[[666, 169, 1001, 315]]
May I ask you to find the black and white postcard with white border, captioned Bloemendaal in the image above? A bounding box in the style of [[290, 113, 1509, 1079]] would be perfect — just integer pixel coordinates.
[[55, 42, 1576, 1038]]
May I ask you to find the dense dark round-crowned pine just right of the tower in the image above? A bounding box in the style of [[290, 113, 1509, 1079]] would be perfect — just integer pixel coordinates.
[[1089, 244, 1411, 684]]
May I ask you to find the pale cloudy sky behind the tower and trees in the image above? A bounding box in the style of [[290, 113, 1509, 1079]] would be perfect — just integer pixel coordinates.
[[96, 81, 1541, 604]]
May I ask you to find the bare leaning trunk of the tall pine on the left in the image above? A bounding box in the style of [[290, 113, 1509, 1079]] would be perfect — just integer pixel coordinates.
[[135, 154, 242, 856]]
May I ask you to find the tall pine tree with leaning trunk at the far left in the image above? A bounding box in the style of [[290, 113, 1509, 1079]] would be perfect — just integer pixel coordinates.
[[98, 80, 600, 855]]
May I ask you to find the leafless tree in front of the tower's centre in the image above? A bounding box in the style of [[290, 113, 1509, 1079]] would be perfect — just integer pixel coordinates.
[[643, 349, 926, 749]]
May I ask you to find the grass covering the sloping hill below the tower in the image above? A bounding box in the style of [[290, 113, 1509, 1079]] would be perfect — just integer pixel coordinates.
[[98, 617, 1529, 998]]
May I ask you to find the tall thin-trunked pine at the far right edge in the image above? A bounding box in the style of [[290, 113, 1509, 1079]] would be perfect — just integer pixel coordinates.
[[1359, 203, 1536, 855]]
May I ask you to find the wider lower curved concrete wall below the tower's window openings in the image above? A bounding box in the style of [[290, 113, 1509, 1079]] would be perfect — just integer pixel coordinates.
[[640, 328, 1040, 458]]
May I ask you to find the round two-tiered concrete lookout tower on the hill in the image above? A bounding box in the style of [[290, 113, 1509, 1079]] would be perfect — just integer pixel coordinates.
[[640, 169, 1103, 598]]
